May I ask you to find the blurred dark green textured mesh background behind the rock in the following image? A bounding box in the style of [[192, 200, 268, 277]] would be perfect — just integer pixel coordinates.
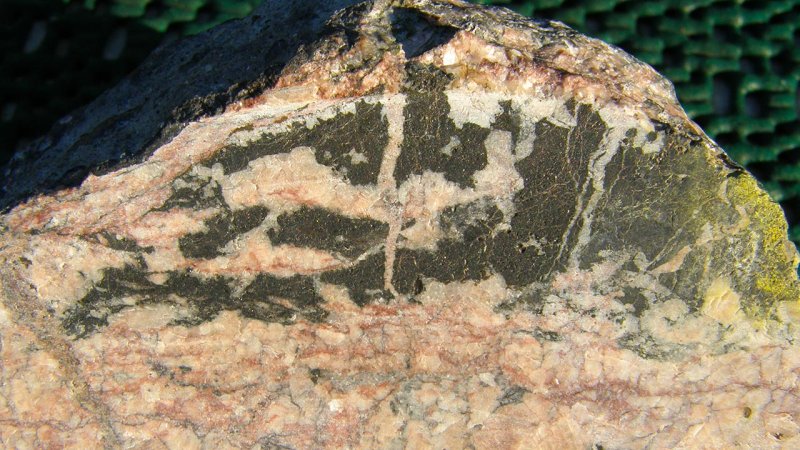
[[0, 0, 800, 243]]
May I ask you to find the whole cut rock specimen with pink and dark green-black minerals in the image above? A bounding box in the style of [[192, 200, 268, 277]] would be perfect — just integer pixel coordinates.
[[0, 0, 800, 448]]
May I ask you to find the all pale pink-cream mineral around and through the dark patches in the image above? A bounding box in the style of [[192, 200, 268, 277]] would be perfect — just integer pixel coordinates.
[[0, 91, 800, 449]]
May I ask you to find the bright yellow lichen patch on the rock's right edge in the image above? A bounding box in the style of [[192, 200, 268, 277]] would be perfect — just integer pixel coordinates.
[[728, 175, 800, 320]]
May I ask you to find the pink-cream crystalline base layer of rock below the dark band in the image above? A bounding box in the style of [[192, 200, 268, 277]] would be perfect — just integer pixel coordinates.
[[0, 264, 788, 448]]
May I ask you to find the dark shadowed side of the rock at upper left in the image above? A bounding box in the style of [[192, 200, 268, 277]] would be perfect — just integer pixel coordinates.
[[0, 0, 357, 211]]
